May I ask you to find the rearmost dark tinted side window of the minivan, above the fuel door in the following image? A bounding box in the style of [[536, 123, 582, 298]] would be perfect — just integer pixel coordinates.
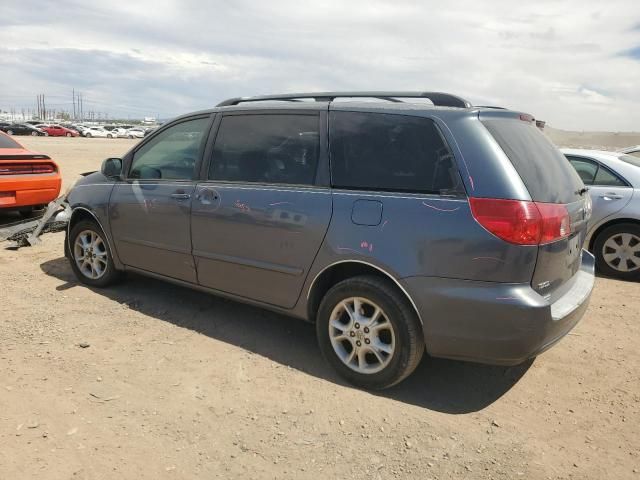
[[329, 112, 464, 194]]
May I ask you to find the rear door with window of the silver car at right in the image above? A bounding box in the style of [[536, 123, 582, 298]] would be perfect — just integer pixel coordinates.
[[567, 155, 633, 228]]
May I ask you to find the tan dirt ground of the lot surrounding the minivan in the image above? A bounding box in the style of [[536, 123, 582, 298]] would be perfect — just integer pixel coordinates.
[[0, 138, 640, 479]]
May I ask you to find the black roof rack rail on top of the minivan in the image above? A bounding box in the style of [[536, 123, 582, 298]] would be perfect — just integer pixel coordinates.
[[216, 91, 472, 108]]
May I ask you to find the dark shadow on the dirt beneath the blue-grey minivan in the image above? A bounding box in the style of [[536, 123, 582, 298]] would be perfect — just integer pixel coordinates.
[[40, 257, 533, 414]]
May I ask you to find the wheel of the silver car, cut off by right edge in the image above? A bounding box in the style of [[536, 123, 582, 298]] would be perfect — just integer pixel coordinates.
[[593, 223, 640, 280]]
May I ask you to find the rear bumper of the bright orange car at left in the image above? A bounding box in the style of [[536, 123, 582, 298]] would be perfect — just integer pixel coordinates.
[[0, 174, 62, 209]]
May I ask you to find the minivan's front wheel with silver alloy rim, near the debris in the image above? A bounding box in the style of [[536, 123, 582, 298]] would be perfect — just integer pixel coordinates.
[[67, 220, 122, 288]]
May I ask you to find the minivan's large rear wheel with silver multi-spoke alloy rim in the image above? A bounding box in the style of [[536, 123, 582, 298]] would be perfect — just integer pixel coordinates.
[[316, 276, 424, 390]]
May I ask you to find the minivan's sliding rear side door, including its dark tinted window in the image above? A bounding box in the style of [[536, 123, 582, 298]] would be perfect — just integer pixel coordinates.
[[191, 107, 331, 308]]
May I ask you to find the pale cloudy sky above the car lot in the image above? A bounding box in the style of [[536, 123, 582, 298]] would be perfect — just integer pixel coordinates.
[[0, 0, 640, 131]]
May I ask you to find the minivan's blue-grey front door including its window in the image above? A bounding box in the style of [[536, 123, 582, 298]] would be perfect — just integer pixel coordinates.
[[109, 116, 210, 283]]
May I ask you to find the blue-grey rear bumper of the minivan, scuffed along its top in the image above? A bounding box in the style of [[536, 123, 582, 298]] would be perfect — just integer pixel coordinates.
[[402, 250, 595, 365]]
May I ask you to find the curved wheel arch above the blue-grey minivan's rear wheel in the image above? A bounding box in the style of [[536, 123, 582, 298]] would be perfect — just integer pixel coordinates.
[[307, 260, 424, 328]]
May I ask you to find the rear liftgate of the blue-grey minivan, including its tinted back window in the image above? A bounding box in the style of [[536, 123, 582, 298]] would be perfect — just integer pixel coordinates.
[[480, 112, 588, 300]]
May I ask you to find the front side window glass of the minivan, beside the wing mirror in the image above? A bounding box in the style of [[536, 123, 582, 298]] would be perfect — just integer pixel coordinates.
[[129, 118, 209, 180]]
